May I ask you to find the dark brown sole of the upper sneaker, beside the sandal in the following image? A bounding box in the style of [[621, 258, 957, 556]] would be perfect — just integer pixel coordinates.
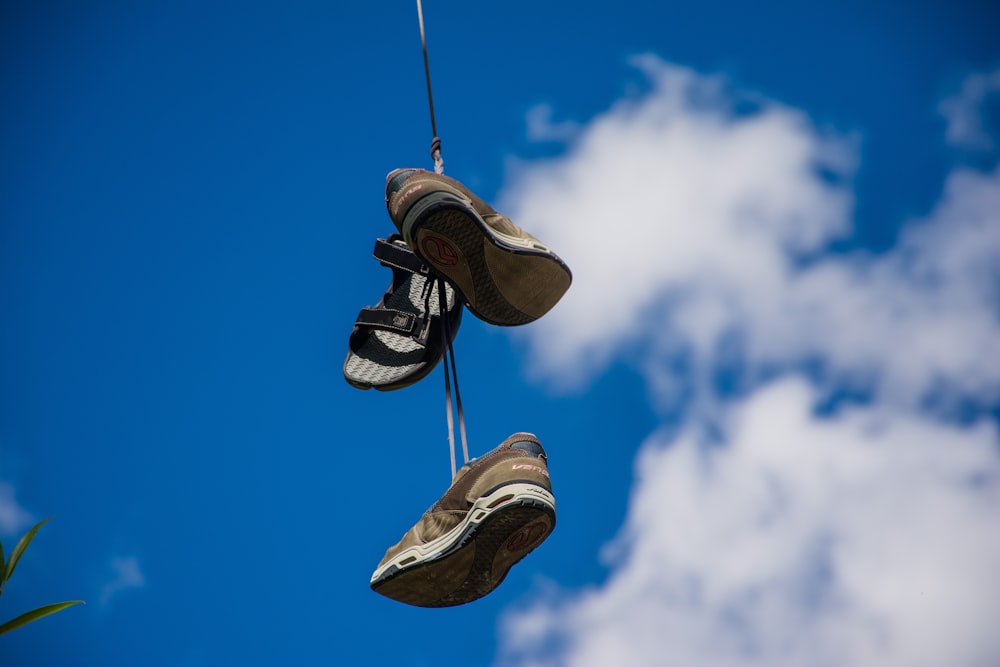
[[401, 191, 572, 326]]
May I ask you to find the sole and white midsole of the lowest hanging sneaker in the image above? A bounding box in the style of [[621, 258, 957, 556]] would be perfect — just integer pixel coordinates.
[[371, 483, 556, 607]]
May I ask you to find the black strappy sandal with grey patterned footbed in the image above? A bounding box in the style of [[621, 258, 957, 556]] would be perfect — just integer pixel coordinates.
[[344, 234, 462, 391]]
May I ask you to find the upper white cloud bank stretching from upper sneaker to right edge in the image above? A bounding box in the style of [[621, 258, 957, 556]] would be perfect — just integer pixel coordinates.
[[502, 57, 1000, 412]]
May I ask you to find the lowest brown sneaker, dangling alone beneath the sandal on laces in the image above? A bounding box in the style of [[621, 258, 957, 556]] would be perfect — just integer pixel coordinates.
[[371, 433, 556, 607]]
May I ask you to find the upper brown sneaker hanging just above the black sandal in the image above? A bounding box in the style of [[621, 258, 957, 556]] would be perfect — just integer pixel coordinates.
[[385, 169, 572, 326]]
